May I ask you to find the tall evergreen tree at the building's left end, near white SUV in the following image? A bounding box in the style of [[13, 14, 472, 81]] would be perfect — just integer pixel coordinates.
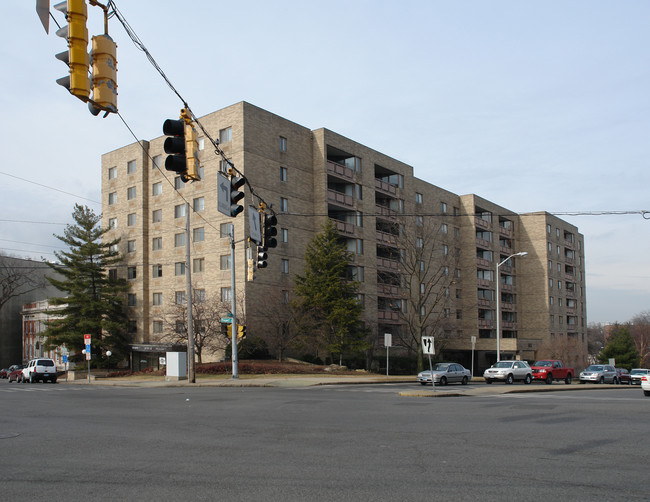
[[45, 204, 129, 360]]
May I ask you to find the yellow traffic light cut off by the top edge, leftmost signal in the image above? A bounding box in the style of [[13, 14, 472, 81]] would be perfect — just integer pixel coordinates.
[[54, 0, 90, 102]]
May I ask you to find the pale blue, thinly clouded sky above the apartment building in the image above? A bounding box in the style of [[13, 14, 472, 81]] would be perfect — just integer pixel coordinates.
[[0, 0, 650, 322]]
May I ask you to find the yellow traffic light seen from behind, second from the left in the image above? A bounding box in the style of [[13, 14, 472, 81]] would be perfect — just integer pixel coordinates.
[[88, 34, 117, 115]]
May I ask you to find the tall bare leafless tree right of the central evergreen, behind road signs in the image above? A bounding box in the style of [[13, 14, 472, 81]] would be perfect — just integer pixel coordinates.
[[390, 216, 458, 369]]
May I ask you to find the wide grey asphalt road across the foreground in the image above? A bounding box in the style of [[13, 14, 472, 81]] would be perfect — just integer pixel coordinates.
[[0, 381, 650, 501]]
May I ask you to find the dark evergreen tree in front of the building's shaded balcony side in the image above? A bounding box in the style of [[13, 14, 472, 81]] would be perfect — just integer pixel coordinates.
[[294, 220, 368, 364]]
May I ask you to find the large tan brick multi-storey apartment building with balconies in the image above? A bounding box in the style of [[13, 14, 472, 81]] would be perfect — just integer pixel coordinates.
[[102, 102, 587, 371]]
